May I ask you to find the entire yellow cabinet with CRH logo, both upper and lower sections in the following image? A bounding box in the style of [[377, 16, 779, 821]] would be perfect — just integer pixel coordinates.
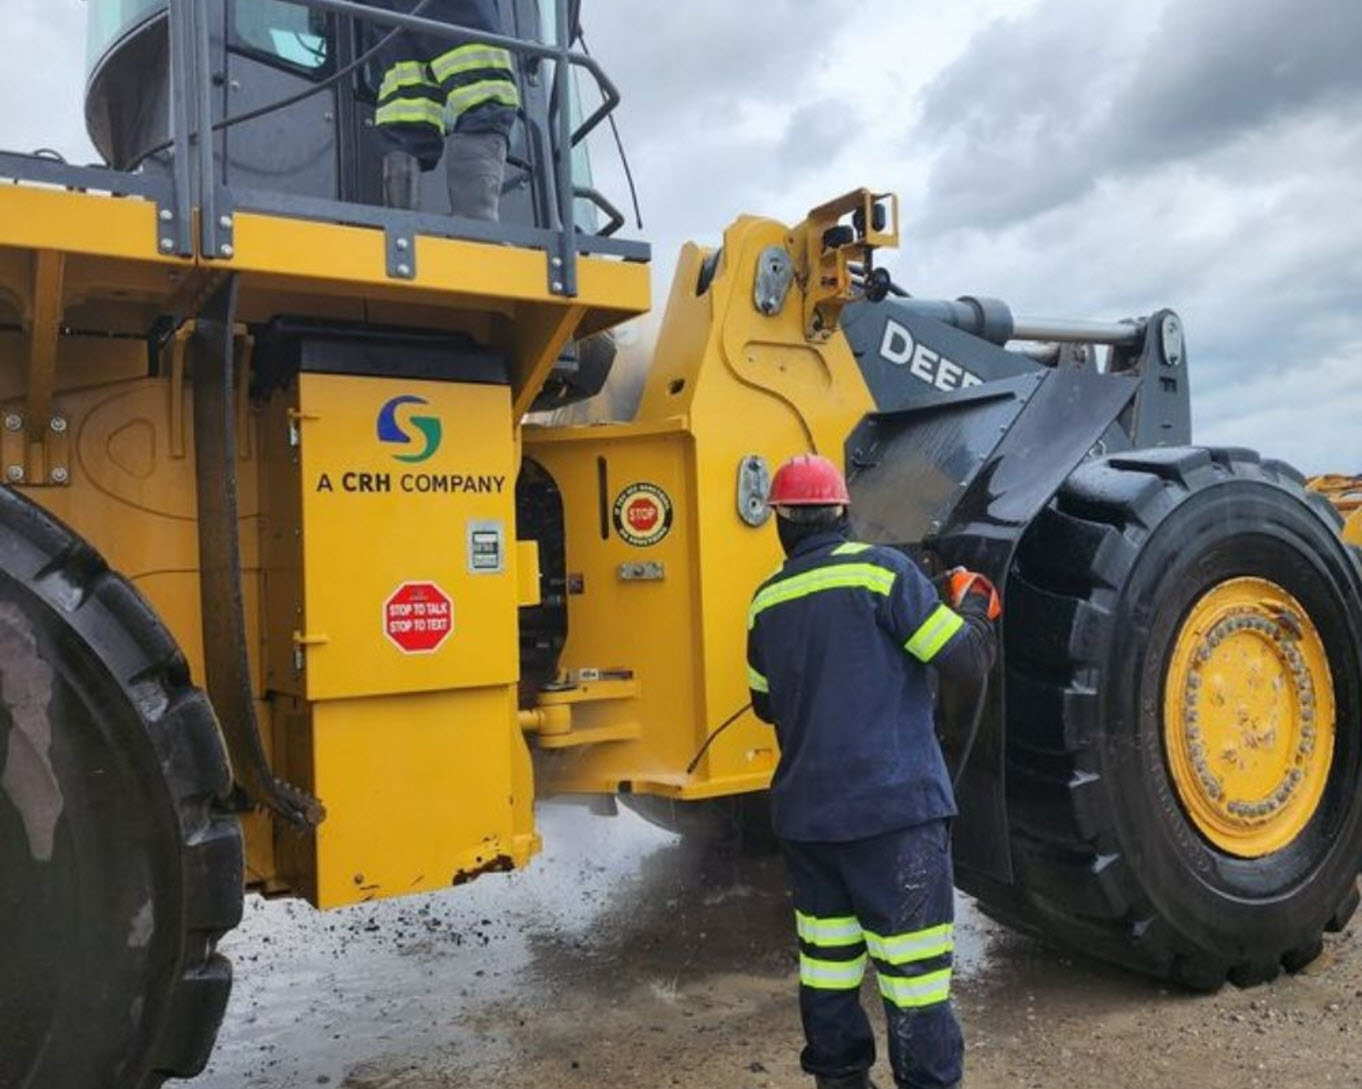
[[262, 373, 538, 907]]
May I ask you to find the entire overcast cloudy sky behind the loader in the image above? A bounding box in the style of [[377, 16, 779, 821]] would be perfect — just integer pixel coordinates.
[[8, 0, 1362, 472]]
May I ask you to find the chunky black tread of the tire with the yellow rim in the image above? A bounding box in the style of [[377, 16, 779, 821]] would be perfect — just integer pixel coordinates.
[[983, 448, 1359, 991]]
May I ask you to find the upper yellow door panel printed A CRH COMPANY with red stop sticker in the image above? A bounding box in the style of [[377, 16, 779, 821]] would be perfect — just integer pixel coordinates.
[[290, 374, 519, 700]]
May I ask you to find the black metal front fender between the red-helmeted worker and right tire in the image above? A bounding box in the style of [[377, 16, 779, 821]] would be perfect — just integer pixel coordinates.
[[846, 369, 1139, 882]]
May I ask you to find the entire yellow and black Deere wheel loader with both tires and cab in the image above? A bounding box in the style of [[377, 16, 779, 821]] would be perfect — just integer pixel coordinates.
[[0, 0, 1362, 1089]]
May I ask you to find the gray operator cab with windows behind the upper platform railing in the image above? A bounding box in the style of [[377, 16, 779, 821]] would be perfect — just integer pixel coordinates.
[[86, 0, 620, 233]]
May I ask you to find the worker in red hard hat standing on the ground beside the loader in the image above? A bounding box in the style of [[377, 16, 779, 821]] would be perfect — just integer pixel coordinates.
[[748, 455, 1000, 1089]]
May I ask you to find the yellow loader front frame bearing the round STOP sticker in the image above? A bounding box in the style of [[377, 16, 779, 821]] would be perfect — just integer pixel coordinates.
[[526, 218, 873, 799]]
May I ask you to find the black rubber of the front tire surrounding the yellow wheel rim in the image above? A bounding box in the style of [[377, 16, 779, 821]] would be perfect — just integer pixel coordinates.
[[985, 448, 1362, 988]]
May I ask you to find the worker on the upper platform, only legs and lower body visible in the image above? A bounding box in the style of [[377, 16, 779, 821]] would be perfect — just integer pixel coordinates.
[[369, 0, 520, 221]]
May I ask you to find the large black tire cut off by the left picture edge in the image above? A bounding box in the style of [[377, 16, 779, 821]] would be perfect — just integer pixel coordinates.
[[0, 489, 242, 1089]]
